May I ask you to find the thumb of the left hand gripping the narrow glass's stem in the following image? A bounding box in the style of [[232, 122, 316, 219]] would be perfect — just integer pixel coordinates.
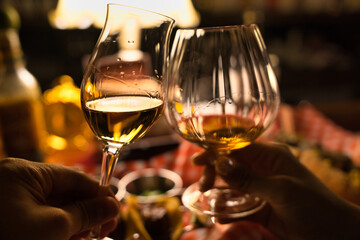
[[63, 196, 120, 234]]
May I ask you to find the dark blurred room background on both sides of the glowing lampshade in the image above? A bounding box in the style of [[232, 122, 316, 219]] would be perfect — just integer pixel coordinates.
[[4, 0, 360, 131]]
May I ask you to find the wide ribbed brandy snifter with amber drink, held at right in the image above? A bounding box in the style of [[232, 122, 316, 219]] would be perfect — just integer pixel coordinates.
[[166, 24, 280, 219]]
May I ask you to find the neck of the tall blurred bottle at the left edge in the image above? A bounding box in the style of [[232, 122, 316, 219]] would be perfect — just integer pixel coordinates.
[[0, 28, 25, 71]]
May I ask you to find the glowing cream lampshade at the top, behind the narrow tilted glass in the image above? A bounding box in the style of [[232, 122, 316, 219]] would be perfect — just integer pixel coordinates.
[[49, 0, 200, 29]]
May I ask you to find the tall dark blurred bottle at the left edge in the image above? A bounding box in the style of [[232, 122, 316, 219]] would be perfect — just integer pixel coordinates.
[[0, 3, 46, 161]]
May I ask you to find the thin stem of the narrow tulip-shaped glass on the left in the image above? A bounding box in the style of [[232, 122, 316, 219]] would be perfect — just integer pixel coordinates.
[[100, 145, 122, 186]]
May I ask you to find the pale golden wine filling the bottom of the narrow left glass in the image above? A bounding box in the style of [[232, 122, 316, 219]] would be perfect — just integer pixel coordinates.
[[84, 96, 164, 145]]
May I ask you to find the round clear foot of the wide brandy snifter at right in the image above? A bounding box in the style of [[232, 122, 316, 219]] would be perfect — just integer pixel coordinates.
[[182, 183, 265, 218]]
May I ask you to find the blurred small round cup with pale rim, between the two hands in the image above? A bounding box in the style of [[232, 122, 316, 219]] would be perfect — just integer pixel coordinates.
[[116, 168, 184, 240]]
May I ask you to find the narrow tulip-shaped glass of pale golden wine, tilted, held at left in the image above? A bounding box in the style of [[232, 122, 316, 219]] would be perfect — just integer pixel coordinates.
[[81, 4, 174, 238]]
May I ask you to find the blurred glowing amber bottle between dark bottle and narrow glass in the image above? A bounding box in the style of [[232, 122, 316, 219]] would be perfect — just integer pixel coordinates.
[[43, 75, 101, 173]]
